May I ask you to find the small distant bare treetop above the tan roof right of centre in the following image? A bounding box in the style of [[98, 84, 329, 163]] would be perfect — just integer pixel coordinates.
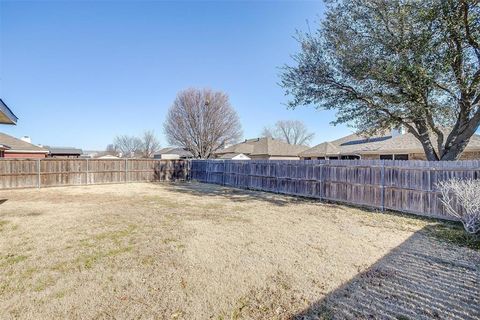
[[262, 120, 315, 145]]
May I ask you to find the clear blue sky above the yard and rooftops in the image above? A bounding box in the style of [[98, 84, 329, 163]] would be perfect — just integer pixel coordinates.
[[0, 1, 350, 149]]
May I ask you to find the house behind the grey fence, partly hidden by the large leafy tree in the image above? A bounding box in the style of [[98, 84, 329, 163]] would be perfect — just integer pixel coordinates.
[[300, 130, 480, 160]]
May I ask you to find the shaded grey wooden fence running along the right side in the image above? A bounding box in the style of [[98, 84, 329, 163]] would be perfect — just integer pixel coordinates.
[[190, 160, 480, 218]]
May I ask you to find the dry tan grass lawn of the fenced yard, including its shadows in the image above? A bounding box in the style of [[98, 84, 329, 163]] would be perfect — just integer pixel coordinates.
[[0, 183, 480, 319]]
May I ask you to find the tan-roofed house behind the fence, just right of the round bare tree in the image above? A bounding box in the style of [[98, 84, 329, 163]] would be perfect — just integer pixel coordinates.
[[215, 138, 308, 160]]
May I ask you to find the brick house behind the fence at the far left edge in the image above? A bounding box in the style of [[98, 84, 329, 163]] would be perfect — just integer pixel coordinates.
[[0, 133, 48, 158]]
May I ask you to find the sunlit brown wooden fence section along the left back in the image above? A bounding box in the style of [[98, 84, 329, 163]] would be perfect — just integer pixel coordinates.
[[0, 159, 190, 189]]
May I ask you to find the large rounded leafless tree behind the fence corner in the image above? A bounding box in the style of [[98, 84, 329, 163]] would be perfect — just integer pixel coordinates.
[[164, 89, 242, 159]]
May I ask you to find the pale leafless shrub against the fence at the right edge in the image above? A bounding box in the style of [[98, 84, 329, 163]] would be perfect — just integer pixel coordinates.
[[437, 178, 480, 234]]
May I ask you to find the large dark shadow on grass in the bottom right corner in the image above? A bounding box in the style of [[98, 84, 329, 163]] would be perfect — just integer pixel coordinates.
[[292, 227, 480, 320]]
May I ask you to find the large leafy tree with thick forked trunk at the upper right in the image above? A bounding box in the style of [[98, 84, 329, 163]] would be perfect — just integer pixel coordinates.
[[281, 0, 480, 160]]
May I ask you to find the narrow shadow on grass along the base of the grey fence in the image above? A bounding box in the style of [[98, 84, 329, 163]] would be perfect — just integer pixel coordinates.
[[163, 182, 344, 208]]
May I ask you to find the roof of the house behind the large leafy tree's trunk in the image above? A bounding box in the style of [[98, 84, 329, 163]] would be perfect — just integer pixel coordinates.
[[300, 133, 480, 157]]
